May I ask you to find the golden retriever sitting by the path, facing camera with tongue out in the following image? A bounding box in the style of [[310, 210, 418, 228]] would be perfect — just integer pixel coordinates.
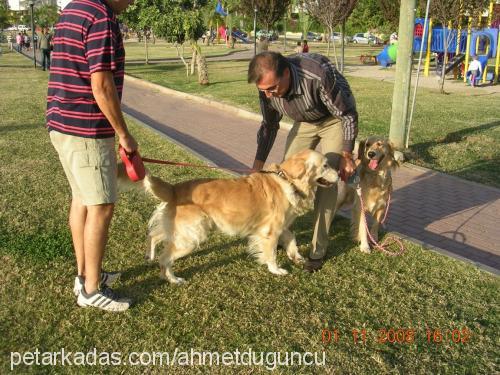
[[337, 137, 399, 253]]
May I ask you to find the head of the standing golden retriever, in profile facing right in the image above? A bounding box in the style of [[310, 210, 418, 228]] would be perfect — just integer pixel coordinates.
[[280, 150, 339, 192]]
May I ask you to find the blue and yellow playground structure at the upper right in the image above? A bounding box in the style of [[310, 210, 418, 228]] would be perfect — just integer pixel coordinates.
[[413, 2, 500, 83]]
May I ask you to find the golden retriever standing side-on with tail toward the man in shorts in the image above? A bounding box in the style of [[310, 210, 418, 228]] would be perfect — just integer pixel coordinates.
[[119, 150, 338, 283]]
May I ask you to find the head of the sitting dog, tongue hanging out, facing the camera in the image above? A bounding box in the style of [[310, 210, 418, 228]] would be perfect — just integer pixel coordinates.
[[358, 136, 399, 171]]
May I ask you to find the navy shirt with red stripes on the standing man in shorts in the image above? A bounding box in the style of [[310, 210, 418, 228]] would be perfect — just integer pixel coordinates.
[[47, 0, 125, 138]]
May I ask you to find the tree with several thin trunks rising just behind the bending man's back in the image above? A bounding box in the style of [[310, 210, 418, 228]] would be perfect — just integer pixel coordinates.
[[304, 0, 357, 67]]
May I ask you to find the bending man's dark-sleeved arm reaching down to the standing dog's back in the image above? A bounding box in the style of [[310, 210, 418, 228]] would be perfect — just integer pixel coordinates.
[[252, 92, 283, 171]]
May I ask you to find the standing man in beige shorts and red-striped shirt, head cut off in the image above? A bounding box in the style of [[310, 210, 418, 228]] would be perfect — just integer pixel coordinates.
[[47, 0, 138, 311]]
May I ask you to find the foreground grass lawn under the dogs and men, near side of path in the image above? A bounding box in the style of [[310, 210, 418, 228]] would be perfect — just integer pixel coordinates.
[[0, 50, 500, 374]]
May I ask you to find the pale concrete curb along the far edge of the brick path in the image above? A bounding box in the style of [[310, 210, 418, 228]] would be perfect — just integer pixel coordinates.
[[125, 74, 292, 130]]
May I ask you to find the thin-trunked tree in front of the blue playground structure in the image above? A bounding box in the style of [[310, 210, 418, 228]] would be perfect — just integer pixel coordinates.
[[420, 0, 489, 93]]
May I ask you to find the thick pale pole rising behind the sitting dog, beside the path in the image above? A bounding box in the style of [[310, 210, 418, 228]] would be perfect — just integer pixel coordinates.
[[389, 0, 416, 149]]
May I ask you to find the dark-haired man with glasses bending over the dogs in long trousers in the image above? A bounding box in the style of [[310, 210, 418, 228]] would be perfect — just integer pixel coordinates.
[[248, 52, 358, 272]]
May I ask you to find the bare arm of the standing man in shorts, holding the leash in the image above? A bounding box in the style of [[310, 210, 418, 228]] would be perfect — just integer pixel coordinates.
[[90, 71, 138, 153]]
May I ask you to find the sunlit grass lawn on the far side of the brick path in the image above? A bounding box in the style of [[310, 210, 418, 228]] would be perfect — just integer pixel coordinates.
[[127, 58, 500, 187]]
